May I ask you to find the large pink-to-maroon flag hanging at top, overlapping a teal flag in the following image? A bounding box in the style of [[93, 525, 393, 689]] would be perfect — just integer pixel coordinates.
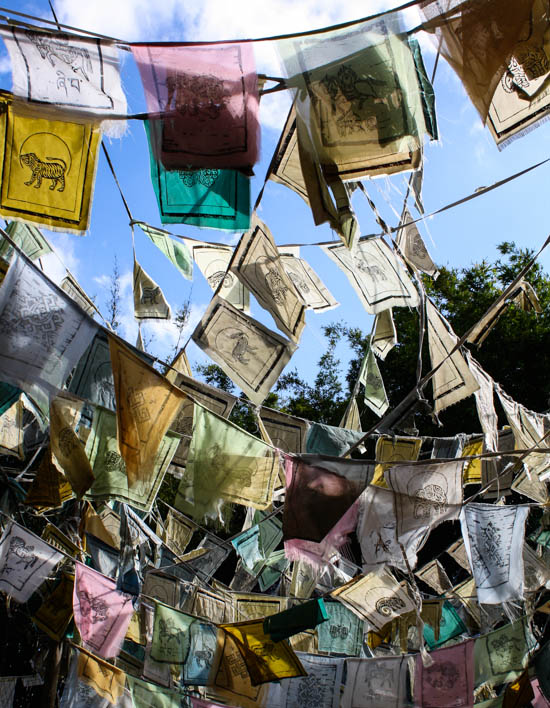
[[132, 43, 260, 169]]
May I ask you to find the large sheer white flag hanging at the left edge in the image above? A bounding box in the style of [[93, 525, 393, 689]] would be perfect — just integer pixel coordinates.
[[0, 255, 97, 405]]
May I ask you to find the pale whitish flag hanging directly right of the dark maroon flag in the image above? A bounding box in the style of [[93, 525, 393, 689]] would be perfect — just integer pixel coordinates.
[[357, 484, 424, 572]]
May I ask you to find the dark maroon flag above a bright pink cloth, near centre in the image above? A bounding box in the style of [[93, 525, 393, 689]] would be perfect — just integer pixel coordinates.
[[283, 457, 368, 543]]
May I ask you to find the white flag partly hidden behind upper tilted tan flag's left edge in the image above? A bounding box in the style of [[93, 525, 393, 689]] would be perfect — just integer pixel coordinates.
[[187, 241, 250, 312]]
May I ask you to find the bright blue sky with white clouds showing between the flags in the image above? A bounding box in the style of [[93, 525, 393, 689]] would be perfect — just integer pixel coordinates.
[[0, 0, 550, 396]]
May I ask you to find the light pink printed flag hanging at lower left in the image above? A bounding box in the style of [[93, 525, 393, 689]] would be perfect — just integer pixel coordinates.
[[73, 563, 134, 659]]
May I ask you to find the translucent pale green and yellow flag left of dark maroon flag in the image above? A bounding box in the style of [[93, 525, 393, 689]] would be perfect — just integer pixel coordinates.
[[175, 403, 279, 519]]
